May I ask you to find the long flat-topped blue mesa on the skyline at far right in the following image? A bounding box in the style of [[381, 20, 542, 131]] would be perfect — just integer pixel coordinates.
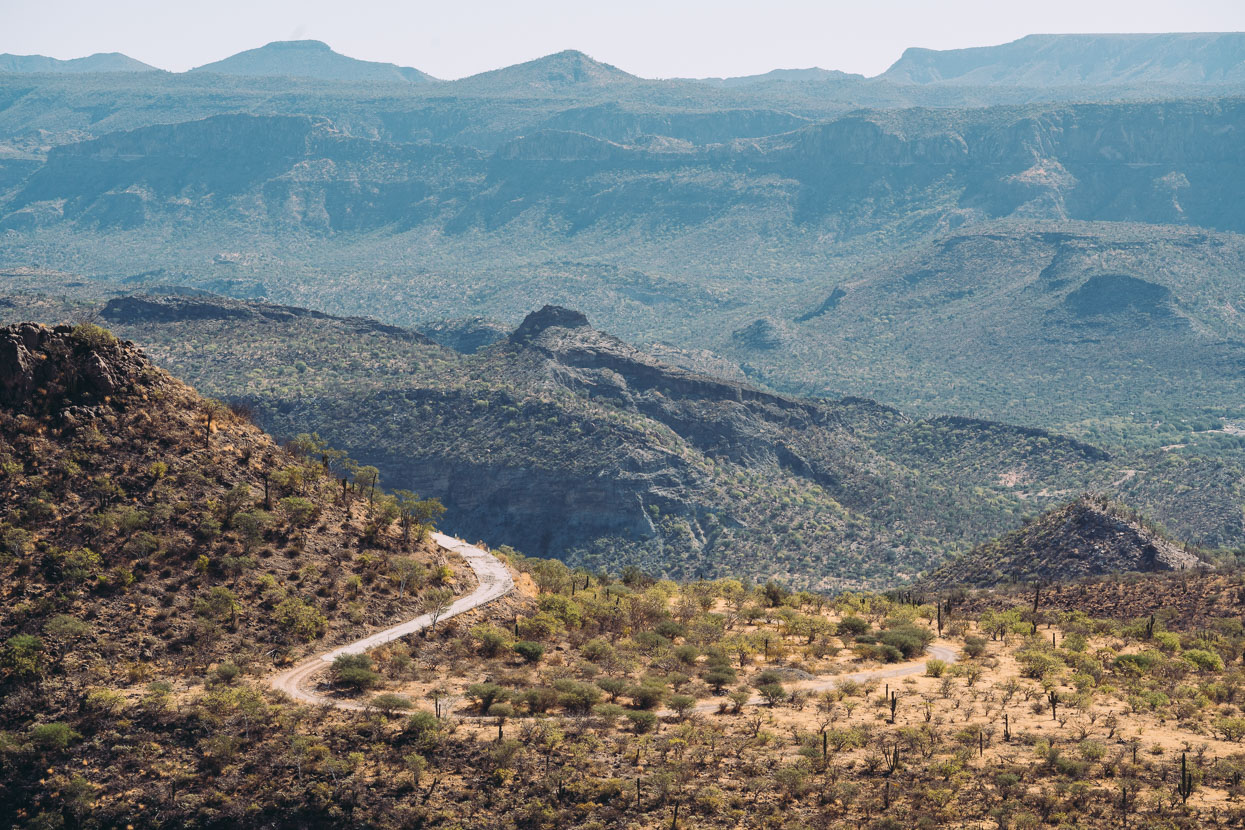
[[879, 32, 1245, 87]]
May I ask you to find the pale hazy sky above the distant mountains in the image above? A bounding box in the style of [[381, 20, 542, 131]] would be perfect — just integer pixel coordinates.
[[0, 0, 1245, 78]]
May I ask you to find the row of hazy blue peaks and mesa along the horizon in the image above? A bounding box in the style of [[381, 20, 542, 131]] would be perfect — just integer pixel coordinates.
[[0, 32, 1245, 91]]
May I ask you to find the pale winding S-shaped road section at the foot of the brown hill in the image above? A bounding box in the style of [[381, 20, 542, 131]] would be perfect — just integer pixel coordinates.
[[269, 533, 514, 712]]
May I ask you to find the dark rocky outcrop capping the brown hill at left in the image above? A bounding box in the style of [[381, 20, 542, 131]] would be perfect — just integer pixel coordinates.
[[0, 322, 158, 414]]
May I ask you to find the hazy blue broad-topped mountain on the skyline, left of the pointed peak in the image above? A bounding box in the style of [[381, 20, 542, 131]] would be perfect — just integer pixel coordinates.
[[190, 40, 436, 83]]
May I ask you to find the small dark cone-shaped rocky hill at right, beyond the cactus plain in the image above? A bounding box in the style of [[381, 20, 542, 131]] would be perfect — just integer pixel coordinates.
[[920, 497, 1204, 590]]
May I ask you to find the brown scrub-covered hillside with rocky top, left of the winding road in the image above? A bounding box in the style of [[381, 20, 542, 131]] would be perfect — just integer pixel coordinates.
[[0, 324, 471, 796]]
